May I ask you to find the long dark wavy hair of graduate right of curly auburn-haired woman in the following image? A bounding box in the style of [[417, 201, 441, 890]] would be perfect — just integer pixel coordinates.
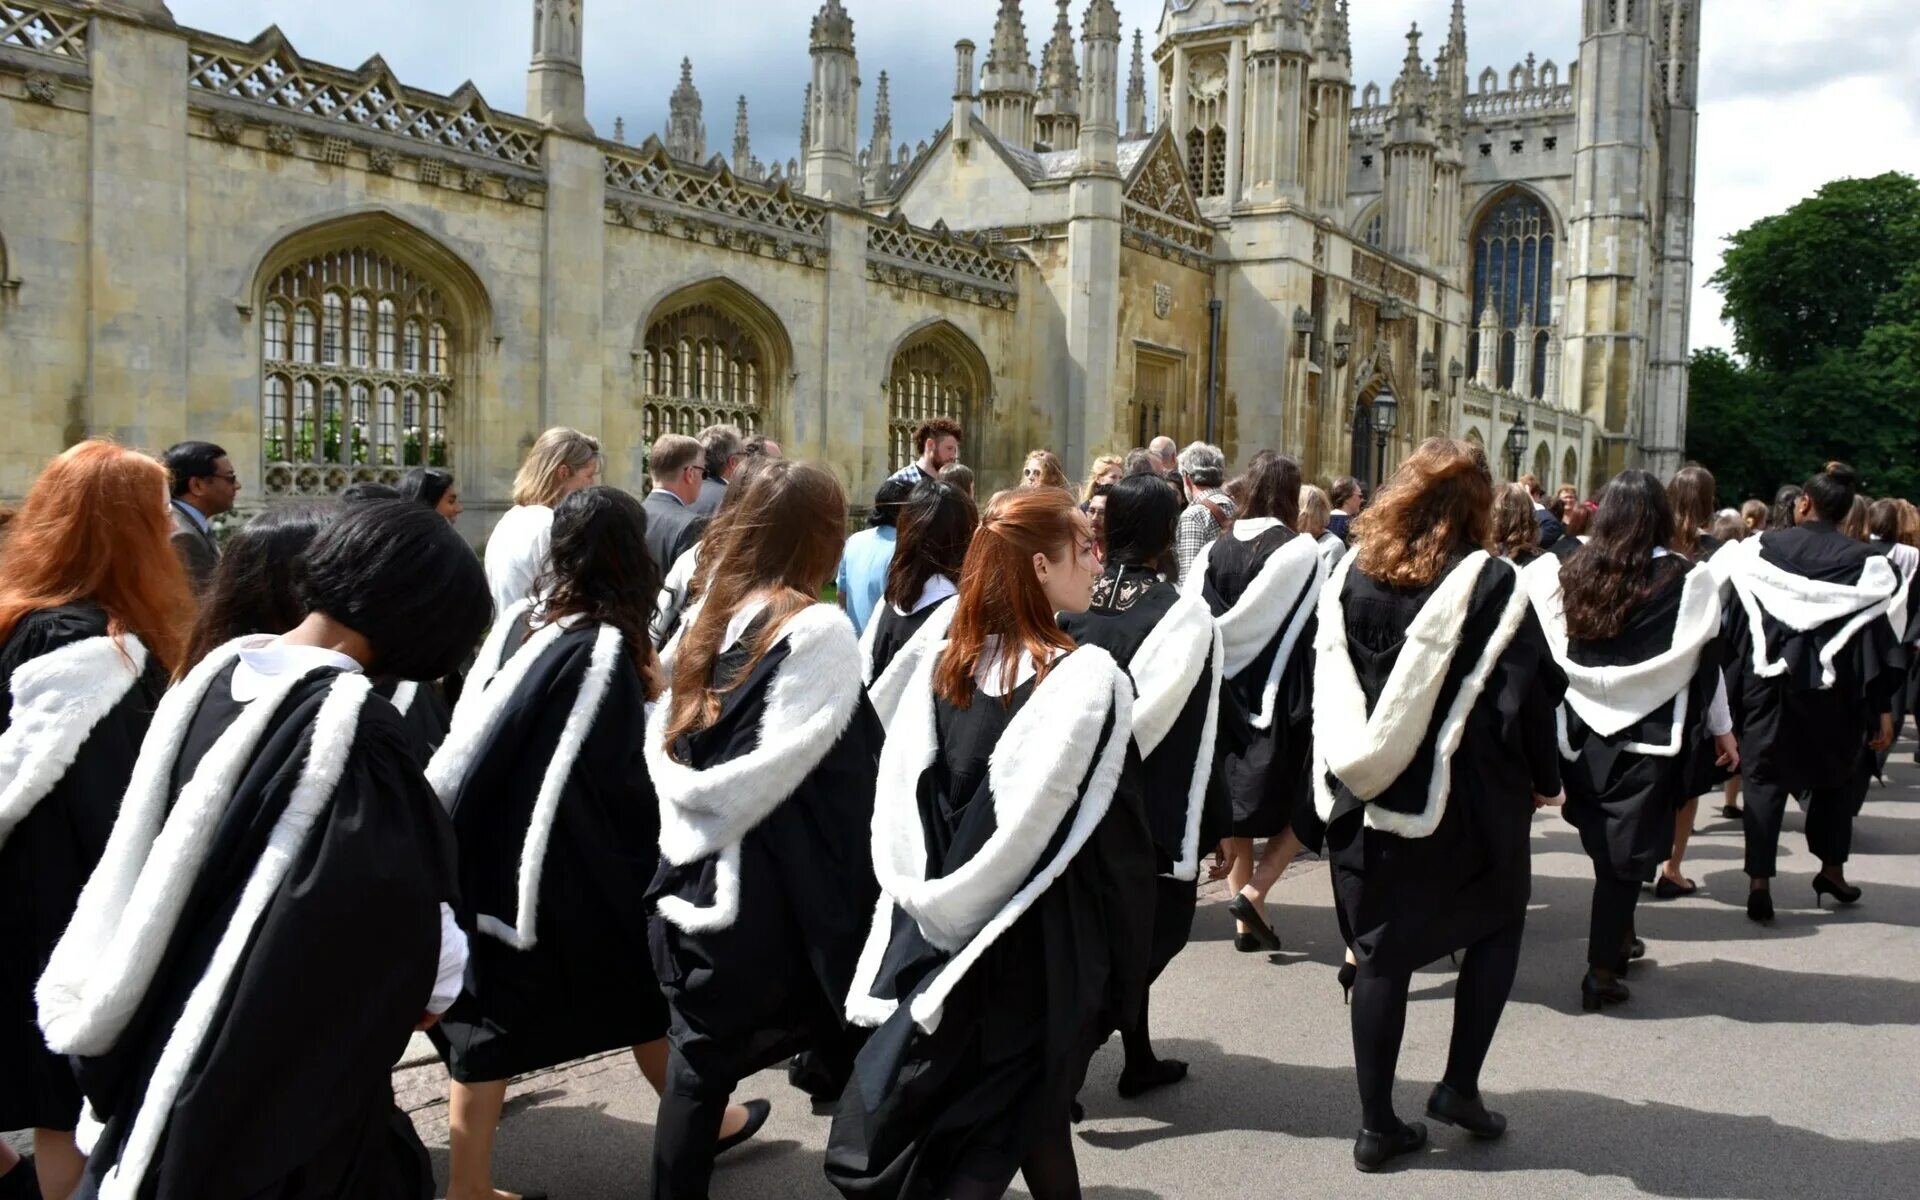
[[1561, 470, 1674, 641]]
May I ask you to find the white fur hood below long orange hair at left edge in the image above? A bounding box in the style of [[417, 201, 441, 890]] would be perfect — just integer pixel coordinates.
[[0, 634, 148, 847]]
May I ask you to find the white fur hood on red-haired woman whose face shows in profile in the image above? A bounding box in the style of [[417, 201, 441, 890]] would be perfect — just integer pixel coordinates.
[[847, 645, 1133, 1031]]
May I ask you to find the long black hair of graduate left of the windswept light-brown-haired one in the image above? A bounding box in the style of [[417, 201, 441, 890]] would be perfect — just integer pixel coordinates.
[[534, 484, 660, 699]]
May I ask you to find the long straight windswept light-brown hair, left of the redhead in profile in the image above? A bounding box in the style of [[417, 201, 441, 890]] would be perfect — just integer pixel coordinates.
[[664, 459, 847, 753]]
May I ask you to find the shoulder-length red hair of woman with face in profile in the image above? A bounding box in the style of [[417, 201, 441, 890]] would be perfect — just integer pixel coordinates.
[[933, 488, 1091, 708]]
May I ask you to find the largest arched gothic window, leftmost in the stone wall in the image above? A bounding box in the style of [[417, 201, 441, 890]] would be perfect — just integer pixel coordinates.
[[259, 248, 455, 495]]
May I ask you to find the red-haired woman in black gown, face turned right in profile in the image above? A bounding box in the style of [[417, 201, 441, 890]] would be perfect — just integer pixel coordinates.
[[828, 488, 1154, 1200]]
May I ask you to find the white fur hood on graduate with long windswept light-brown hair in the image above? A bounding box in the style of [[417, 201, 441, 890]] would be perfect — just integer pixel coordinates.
[[647, 605, 860, 933]]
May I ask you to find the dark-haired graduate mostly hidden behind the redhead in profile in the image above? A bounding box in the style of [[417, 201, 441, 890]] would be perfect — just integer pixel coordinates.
[[860, 480, 979, 724]]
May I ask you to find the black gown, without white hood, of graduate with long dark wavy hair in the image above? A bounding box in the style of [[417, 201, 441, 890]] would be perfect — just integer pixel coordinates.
[[1561, 555, 1720, 883]]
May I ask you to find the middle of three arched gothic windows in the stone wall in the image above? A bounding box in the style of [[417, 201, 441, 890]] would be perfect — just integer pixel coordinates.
[[639, 301, 770, 444]]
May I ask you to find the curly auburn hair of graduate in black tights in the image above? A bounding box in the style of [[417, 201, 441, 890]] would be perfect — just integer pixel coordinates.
[[1354, 438, 1494, 588]]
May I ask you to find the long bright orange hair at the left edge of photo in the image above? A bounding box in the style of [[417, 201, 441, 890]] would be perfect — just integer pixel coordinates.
[[0, 440, 194, 674]]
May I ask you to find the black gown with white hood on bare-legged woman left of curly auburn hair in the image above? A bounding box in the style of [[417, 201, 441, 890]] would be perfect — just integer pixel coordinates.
[[1183, 518, 1327, 845]]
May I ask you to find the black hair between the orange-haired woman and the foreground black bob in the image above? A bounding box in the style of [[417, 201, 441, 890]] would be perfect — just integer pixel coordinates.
[[186, 505, 332, 666]]
